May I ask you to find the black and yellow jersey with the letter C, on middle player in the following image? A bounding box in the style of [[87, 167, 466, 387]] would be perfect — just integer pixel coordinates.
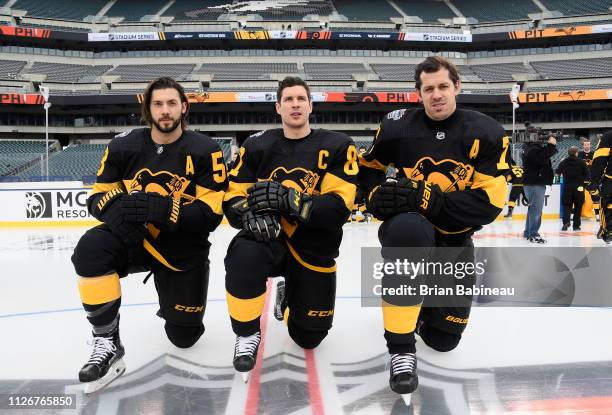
[[225, 128, 358, 262]]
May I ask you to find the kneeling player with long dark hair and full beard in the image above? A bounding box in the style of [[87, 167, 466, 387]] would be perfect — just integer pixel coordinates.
[[72, 77, 227, 393]]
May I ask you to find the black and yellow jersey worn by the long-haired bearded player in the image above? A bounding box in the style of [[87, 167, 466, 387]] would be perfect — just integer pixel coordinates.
[[88, 128, 227, 270]]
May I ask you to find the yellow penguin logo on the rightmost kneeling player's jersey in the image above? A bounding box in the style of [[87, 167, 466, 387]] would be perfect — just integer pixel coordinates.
[[404, 157, 474, 192]]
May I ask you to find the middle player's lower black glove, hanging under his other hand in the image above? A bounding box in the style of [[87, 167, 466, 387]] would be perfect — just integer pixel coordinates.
[[227, 198, 281, 242]]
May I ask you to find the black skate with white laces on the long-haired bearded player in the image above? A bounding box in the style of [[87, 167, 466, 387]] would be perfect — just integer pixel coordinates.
[[79, 328, 125, 394]]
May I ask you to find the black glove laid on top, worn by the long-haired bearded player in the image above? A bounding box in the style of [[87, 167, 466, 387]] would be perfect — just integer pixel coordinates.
[[121, 192, 181, 231]]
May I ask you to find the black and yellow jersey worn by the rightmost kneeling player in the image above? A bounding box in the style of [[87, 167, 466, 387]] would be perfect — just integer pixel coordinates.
[[360, 108, 511, 235]]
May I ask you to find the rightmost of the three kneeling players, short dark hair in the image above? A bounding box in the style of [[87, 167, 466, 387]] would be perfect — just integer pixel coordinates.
[[359, 56, 511, 401]]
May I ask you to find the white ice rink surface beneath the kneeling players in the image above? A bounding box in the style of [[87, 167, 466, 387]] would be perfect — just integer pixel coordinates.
[[0, 220, 612, 415]]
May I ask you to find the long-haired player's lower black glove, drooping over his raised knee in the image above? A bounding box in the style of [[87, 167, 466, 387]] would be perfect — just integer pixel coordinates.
[[91, 189, 147, 248]]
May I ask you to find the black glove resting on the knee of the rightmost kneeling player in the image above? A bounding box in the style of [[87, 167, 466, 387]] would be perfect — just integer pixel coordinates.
[[367, 178, 444, 220]]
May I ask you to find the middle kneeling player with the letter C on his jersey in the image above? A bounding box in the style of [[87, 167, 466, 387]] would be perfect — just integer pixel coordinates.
[[223, 77, 358, 380]]
